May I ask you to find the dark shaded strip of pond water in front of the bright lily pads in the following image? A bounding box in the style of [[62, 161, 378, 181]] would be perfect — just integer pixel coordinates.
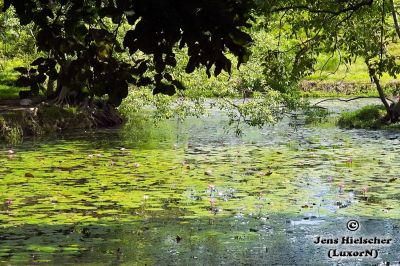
[[0, 215, 400, 265]]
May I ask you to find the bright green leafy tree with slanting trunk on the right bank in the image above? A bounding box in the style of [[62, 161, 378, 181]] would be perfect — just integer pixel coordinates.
[[259, 0, 400, 122]]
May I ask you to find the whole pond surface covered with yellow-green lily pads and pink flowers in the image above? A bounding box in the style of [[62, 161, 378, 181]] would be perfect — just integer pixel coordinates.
[[0, 101, 400, 265]]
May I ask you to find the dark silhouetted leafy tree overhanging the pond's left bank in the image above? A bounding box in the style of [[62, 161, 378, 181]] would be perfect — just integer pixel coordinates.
[[3, 0, 253, 106]]
